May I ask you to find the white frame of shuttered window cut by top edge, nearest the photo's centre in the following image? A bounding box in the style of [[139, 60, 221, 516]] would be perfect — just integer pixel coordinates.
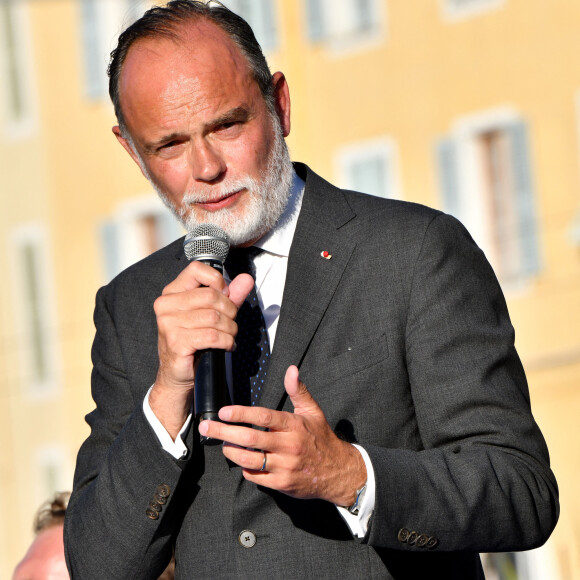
[[303, 0, 388, 56]]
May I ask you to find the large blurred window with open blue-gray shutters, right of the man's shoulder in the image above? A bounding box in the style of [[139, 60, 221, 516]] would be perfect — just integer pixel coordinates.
[[438, 109, 540, 284]]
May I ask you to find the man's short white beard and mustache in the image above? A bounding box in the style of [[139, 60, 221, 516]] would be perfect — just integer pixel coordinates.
[[148, 115, 294, 246]]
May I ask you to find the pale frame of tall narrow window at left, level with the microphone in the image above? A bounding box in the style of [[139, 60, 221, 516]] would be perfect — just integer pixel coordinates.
[[10, 223, 61, 399]]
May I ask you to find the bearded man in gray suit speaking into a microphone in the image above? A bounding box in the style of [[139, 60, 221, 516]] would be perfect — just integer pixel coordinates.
[[65, 0, 558, 579]]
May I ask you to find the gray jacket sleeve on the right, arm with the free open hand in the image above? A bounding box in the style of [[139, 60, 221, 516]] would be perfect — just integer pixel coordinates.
[[363, 215, 559, 553]]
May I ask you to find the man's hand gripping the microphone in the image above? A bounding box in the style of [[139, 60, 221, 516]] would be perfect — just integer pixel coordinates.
[[149, 261, 254, 440]]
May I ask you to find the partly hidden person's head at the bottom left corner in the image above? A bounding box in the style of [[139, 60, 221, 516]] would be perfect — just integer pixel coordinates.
[[12, 492, 70, 580]]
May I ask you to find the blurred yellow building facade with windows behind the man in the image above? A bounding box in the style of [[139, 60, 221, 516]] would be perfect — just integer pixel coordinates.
[[0, 0, 580, 580]]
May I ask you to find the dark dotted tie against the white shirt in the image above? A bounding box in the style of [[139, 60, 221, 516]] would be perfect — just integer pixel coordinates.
[[225, 246, 270, 405]]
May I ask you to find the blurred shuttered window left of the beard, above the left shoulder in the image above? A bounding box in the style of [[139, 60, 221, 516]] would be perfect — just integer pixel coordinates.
[[100, 196, 184, 281]]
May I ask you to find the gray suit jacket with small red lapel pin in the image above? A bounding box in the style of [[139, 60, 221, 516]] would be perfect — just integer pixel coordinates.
[[65, 164, 558, 580]]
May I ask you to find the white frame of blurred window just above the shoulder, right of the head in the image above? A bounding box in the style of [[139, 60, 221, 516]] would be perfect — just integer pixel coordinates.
[[335, 136, 403, 199]]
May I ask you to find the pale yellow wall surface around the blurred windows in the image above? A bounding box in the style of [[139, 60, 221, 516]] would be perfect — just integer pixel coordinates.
[[0, 0, 580, 579]]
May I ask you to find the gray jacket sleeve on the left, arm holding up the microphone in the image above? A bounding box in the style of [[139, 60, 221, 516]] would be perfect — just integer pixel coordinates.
[[65, 287, 187, 580]]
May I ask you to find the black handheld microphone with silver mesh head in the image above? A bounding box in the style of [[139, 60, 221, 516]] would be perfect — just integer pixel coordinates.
[[183, 224, 230, 445]]
